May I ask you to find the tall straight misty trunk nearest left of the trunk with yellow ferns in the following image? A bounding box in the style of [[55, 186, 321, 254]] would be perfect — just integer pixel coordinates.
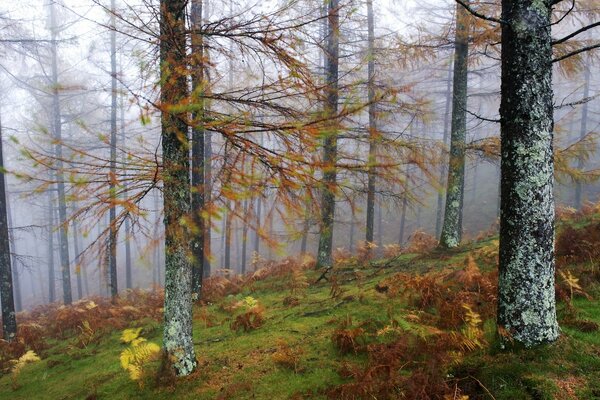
[[108, 0, 119, 301]]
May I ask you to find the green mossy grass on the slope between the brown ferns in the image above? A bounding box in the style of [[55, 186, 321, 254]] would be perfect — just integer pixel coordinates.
[[0, 233, 600, 400]]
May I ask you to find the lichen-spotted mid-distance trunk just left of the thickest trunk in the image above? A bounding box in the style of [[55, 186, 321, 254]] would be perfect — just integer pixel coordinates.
[[440, 3, 469, 248]]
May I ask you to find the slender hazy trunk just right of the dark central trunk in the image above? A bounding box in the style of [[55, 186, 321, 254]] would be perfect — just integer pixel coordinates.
[[365, 0, 379, 247]]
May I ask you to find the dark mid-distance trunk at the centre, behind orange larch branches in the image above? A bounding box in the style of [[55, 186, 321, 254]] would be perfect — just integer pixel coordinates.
[[317, 0, 340, 267]]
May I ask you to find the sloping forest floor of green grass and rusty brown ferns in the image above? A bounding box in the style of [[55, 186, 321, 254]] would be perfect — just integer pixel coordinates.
[[0, 209, 600, 400]]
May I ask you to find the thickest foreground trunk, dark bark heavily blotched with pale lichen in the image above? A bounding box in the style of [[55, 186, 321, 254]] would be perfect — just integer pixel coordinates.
[[498, 0, 559, 347]]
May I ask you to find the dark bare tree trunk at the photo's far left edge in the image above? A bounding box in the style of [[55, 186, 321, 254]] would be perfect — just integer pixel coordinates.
[[0, 115, 17, 342]]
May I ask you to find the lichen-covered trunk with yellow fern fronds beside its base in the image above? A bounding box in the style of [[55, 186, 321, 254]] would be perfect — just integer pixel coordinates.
[[160, 0, 197, 376]]
